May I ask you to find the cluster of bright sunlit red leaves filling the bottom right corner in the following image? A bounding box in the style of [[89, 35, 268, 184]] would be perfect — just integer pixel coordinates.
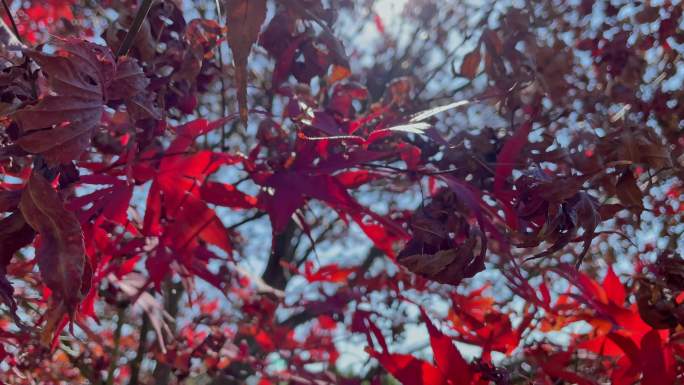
[[352, 265, 684, 385]]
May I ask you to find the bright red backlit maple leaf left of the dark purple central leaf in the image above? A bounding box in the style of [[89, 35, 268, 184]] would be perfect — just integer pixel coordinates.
[[142, 118, 240, 287]]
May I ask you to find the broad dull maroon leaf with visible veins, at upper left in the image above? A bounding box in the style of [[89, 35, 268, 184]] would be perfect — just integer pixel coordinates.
[[12, 38, 149, 166]]
